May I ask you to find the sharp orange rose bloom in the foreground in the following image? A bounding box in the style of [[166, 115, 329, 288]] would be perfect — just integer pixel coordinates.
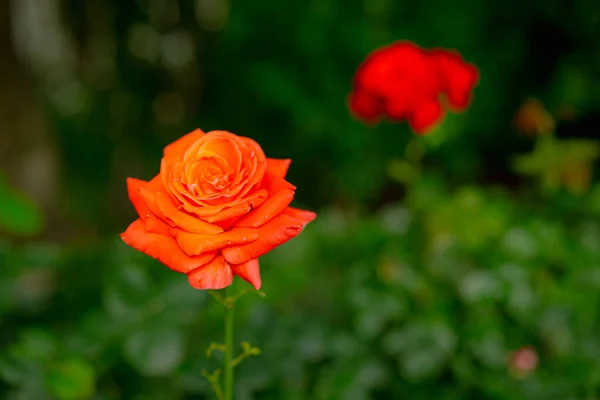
[[121, 129, 316, 289]]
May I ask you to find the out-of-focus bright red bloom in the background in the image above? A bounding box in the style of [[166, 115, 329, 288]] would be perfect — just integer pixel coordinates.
[[348, 41, 479, 134]]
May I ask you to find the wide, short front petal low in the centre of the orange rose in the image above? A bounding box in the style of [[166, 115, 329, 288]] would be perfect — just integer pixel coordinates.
[[177, 228, 258, 256]]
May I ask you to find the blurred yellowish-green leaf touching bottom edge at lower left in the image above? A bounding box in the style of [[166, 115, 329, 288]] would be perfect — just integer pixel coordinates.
[[46, 358, 96, 400]]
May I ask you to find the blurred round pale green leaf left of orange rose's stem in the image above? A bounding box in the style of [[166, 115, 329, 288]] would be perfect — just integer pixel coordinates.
[[124, 326, 184, 376]]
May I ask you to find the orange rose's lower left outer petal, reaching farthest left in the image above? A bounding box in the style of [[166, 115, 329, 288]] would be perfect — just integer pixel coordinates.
[[121, 219, 217, 273]]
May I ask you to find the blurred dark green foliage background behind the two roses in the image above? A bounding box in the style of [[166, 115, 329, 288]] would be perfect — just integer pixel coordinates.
[[0, 0, 600, 400]]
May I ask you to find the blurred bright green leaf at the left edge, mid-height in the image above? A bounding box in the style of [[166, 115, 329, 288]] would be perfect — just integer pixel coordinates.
[[0, 173, 44, 236]]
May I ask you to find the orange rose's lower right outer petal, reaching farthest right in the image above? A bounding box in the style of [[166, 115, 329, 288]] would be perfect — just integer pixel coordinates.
[[222, 206, 314, 264]]
